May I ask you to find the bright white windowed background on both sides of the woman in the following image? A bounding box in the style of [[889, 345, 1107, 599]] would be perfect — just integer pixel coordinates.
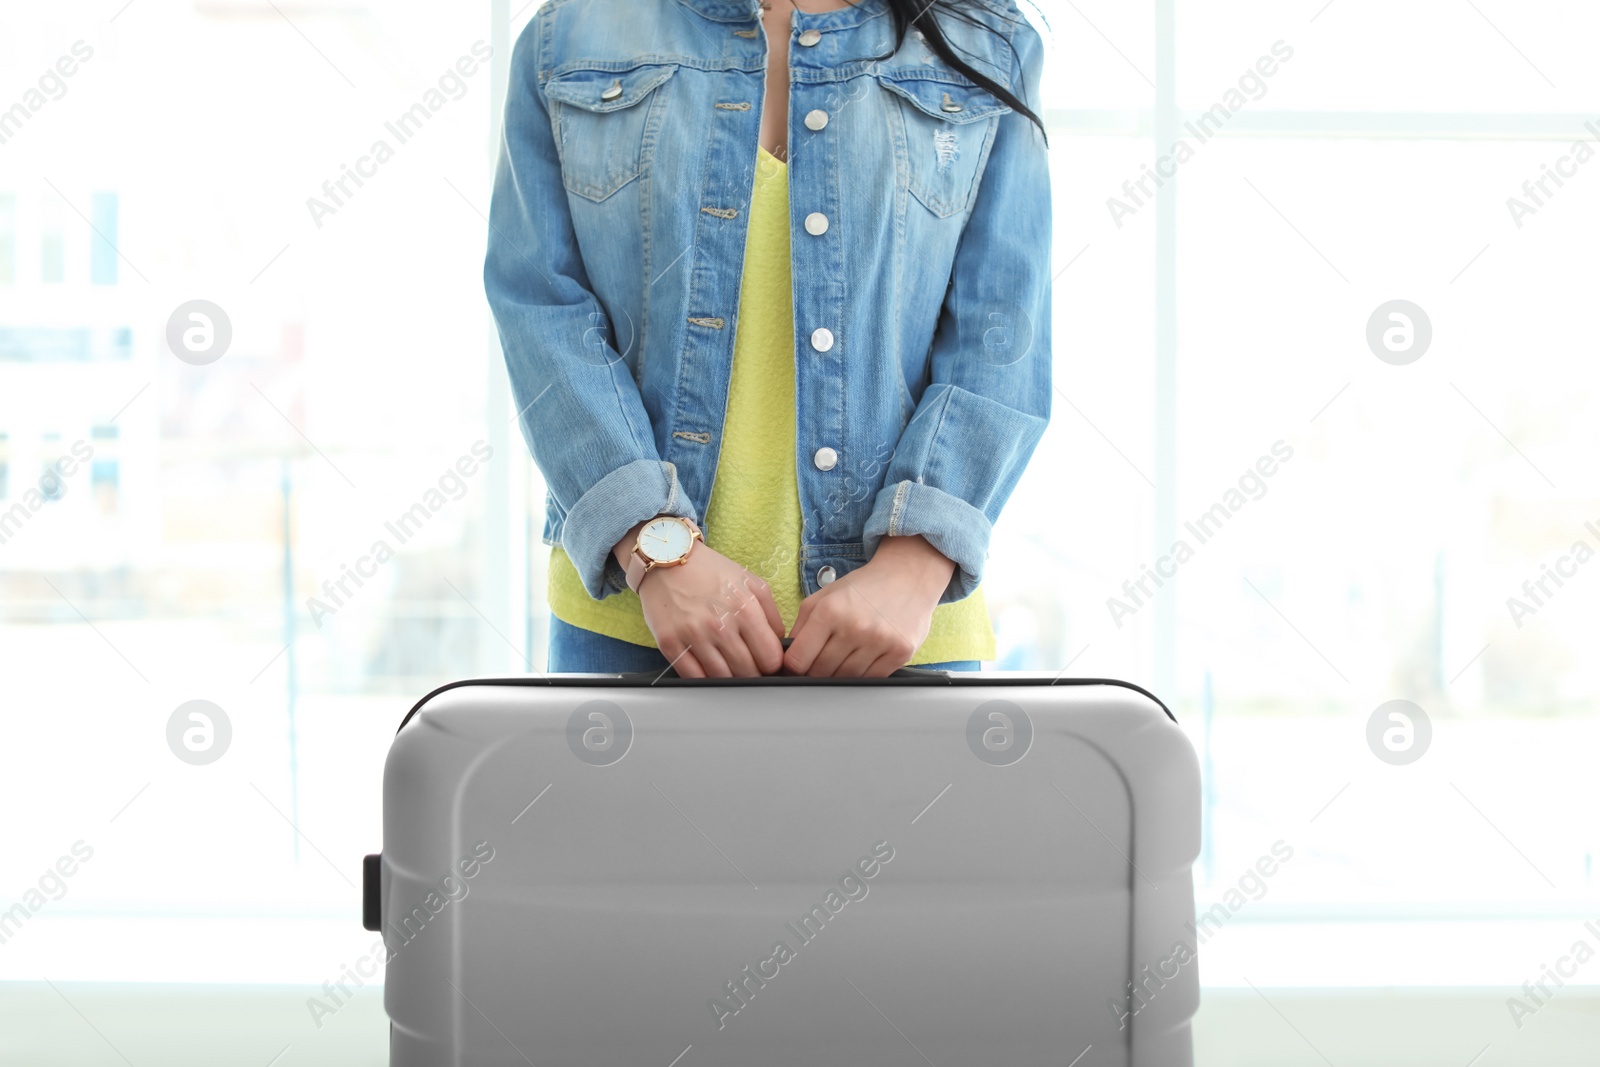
[[0, 0, 1600, 1064]]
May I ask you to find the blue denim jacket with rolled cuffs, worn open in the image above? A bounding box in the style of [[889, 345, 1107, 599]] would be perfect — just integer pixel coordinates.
[[485, 0, 1051, 603]]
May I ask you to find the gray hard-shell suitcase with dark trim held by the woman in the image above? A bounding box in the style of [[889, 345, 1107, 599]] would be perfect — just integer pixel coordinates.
[[365, 670, 1200, 1067]]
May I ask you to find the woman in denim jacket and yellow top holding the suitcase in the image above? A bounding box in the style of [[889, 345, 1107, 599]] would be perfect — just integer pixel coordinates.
[[485, 0, 1050, 678]]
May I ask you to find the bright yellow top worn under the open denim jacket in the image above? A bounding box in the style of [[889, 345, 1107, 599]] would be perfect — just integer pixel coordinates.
[[547, 141, 995, 664]]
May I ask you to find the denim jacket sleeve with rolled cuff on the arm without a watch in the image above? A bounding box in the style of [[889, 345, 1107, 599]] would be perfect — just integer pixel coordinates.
[[862, 21, 1051, 603]]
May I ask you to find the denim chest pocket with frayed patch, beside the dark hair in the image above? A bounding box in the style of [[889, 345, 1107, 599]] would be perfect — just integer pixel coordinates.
[[878, 74, 1011, 218]]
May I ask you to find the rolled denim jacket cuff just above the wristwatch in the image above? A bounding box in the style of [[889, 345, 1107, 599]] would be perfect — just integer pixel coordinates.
[[562, 459, 699, 600]]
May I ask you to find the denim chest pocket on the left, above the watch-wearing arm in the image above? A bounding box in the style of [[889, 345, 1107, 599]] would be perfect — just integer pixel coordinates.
[[544, 66, 677, 200]]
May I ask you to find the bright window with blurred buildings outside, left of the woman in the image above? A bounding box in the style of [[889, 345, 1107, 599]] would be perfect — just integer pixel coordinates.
[[0, 0, 499, 984]]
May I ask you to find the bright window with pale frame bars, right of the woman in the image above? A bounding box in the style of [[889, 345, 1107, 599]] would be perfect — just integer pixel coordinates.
[[1024, 2, 1600, 985]]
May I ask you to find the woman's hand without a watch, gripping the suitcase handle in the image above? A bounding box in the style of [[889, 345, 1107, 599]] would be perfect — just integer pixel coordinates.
[[784, 534, 955, 678]]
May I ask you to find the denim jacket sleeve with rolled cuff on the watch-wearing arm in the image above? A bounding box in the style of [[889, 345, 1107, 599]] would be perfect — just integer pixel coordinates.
[[483, 16, 698, 600]]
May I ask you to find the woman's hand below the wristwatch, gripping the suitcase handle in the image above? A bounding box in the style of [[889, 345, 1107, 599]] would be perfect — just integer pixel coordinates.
[[617, 542, 784, 678]]
